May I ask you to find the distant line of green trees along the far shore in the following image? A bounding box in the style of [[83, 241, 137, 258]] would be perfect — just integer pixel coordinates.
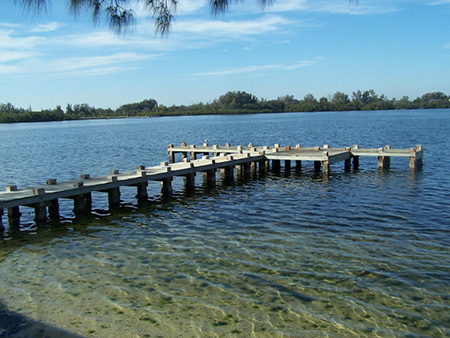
[[0, 89, 450, 123]]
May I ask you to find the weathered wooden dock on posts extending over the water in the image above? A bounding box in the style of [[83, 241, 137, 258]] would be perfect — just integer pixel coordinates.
[[0, 143, 423, 225]]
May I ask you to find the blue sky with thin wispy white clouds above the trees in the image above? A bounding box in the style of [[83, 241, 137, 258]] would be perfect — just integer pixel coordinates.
[[0, 0, 450, 110]]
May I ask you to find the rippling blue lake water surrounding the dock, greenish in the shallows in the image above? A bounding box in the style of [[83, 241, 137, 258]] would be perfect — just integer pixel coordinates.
[[0, 109, 450, 337]]
